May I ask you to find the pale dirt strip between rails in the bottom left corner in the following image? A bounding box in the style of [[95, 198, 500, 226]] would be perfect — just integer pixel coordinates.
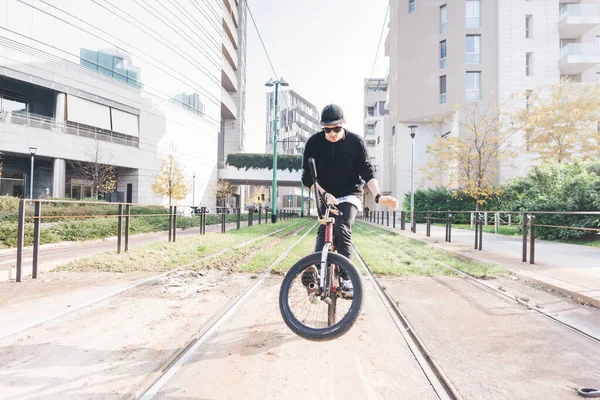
[[0, 271, 252, 400]]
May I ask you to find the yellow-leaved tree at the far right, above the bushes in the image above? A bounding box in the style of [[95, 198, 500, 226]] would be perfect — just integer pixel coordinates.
[[516, 79, 600, 163]]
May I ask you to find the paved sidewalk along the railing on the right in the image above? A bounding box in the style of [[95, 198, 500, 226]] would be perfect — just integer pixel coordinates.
[[362, 221, 600, 307]]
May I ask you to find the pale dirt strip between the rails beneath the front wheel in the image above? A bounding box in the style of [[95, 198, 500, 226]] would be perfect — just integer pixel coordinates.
[[150, 277, 437, 399]]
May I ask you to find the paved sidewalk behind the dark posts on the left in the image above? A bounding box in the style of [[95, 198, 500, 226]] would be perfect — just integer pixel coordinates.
[[0, 221, 247, 282]]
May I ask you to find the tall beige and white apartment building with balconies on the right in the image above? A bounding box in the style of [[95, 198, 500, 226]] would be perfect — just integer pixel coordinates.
[[385, 0, 600, 205]]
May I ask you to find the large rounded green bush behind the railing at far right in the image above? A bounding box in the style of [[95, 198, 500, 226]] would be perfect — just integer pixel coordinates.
[[503, 161, 600, 240]]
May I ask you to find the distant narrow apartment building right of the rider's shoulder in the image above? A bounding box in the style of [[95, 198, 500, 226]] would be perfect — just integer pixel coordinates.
[[363, 78, 392, 210]]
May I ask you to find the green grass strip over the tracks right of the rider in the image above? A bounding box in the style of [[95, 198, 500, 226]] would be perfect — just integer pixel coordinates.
[[352, 224, 506, 278]]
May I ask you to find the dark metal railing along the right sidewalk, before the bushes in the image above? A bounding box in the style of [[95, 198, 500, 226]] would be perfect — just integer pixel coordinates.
[[359, 211, 600, 264]]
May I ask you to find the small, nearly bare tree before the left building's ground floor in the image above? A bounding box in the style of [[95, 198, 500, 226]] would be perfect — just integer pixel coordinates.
[[70, 140, 117, 200]]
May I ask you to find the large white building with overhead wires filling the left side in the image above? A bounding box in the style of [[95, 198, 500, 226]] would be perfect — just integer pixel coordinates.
[[0, 0, 246, 205]]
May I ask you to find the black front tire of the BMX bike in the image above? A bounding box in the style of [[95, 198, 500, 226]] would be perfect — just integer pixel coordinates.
[[279, 252, 363, 342]]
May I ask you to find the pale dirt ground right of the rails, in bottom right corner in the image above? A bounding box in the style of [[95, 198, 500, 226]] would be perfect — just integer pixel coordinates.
[[384, 278, 600, 400]]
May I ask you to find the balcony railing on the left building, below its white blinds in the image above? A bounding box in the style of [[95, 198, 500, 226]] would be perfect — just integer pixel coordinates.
[[0, 111, 140, 147]]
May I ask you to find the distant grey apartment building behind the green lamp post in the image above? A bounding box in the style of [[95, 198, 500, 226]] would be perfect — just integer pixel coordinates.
[[265, 90, 321, 208]]
